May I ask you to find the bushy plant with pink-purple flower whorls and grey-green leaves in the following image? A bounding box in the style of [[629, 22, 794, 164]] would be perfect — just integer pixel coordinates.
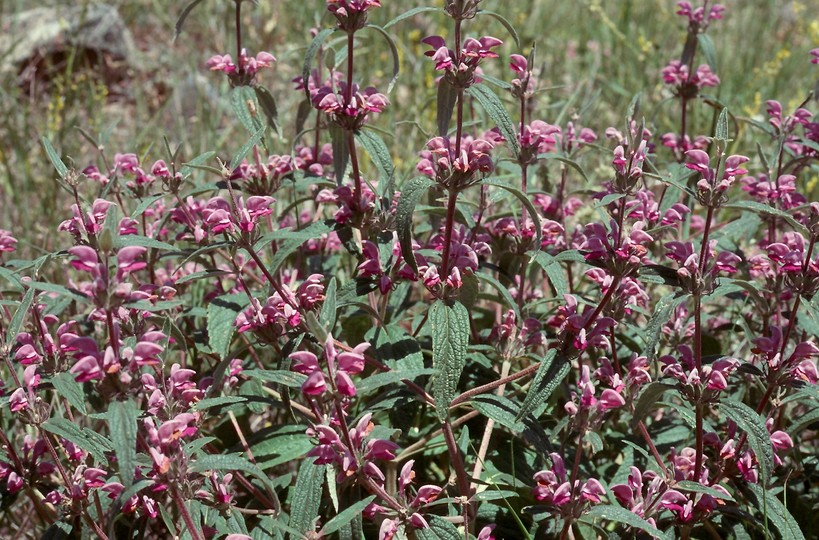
[[0, 0, 819, 540]]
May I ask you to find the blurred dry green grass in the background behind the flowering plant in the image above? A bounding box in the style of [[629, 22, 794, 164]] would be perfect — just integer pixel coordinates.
[[0, 0, 819, 254]]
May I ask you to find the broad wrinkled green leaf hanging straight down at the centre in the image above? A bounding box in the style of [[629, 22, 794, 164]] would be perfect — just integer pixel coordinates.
[[429, 300, 469, 421]]
